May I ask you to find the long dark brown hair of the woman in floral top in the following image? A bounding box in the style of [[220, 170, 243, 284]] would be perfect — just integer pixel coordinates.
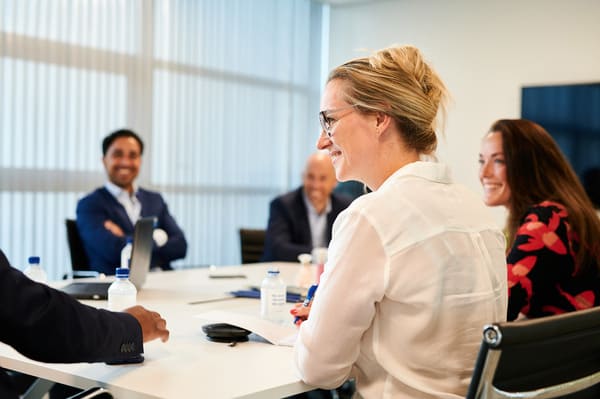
[[490, 119, 600, 275]]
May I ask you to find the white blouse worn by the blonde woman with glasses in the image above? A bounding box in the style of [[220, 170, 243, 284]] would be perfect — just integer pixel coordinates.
[[294, 161, 507, 399]]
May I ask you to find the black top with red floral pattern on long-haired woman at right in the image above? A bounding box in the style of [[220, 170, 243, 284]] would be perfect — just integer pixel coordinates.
[[506, 201, 600, 320]]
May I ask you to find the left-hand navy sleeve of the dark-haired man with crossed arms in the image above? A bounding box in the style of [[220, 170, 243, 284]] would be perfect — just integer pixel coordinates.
[[77, 191, 131, 274]]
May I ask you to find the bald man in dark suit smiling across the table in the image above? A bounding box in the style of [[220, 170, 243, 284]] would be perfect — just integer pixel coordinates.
[[261, 153, 352, 262]]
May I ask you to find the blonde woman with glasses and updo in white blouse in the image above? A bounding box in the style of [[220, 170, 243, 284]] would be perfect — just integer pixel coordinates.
[[293, 46, 507, 399]]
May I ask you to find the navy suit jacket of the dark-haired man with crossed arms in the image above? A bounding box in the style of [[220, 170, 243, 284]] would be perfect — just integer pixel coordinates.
[[77, 187, 187, 274]]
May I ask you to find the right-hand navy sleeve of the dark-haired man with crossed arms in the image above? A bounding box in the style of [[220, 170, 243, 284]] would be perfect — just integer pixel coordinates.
[[152, 196, 187, 267]]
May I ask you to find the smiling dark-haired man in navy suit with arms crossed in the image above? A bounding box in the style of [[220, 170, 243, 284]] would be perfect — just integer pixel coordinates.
[[77, 130, 187, 274]]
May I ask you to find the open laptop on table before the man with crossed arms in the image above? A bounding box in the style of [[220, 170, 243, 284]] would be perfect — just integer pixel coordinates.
[[60, 217, 156, 300]]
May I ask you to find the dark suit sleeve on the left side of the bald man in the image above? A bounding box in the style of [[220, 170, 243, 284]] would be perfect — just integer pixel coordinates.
[[261, 198, 312, 262]]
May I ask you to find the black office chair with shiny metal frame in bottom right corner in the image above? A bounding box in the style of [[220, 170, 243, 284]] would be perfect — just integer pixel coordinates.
[[467, 307, 600, 399]]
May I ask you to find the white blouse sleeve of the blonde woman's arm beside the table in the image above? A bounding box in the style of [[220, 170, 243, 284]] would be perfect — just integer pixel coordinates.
[[294, 211, 388, 388]]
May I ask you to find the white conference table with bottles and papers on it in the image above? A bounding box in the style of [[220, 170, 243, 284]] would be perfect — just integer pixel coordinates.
[[0, 263, 313, 399]]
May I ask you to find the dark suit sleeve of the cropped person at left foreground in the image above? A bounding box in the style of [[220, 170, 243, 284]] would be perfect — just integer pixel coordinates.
[[0, 251, 143, 363]]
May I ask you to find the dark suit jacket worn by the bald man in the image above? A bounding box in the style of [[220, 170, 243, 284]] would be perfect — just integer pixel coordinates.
[[261, 187, 352, 262]]
